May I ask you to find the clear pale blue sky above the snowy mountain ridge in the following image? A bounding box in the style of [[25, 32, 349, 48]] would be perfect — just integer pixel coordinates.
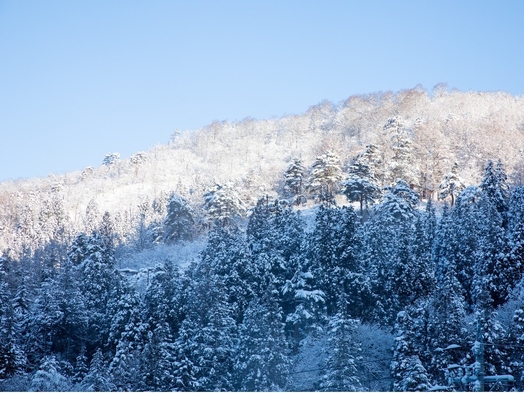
[[0, 0, 524, 181]]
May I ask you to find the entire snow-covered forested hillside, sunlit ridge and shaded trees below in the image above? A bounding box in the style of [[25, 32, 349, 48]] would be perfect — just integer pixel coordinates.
[[0, 86, 524, 391]]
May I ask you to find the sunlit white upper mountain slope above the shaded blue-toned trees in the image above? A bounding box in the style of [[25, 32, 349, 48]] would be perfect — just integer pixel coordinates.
[[0, 86, 524, 250]]
